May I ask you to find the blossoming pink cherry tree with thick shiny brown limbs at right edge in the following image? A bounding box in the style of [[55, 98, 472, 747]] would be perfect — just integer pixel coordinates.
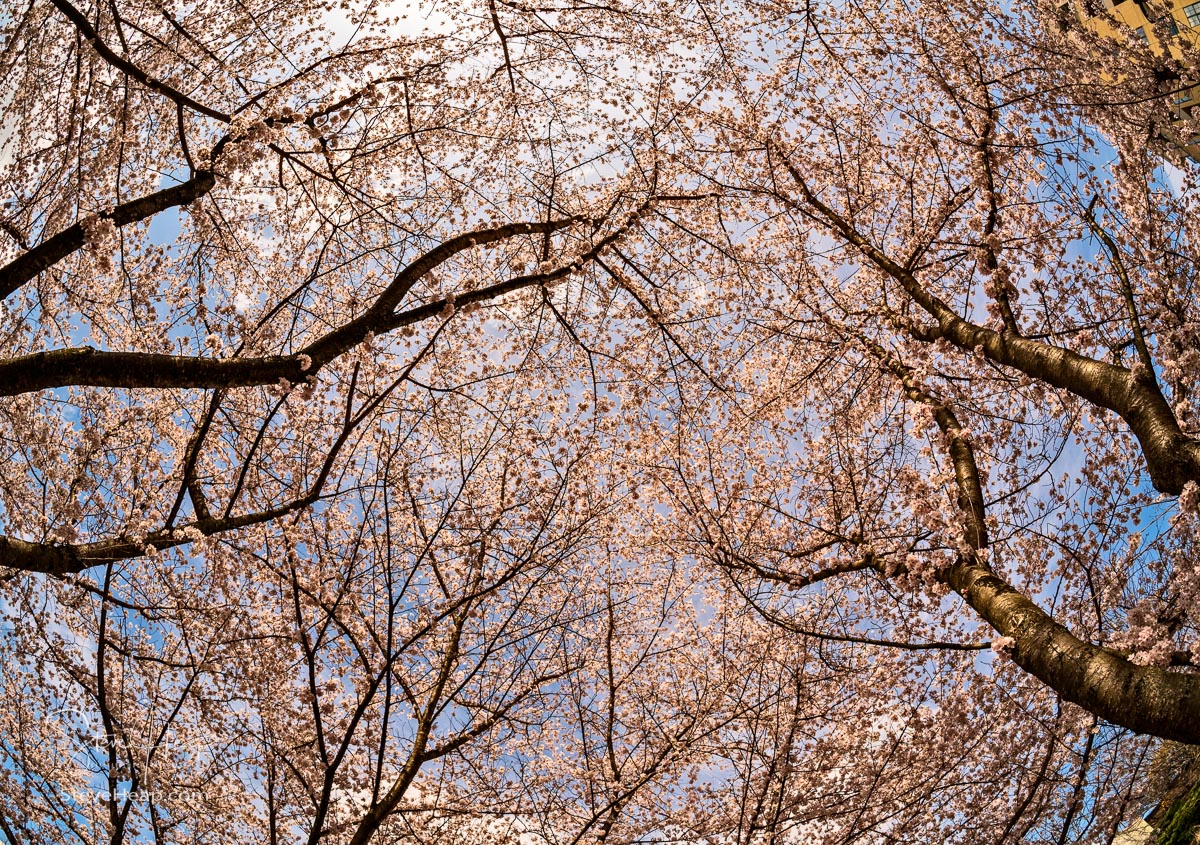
[[659, 2, 1200, 841]]
